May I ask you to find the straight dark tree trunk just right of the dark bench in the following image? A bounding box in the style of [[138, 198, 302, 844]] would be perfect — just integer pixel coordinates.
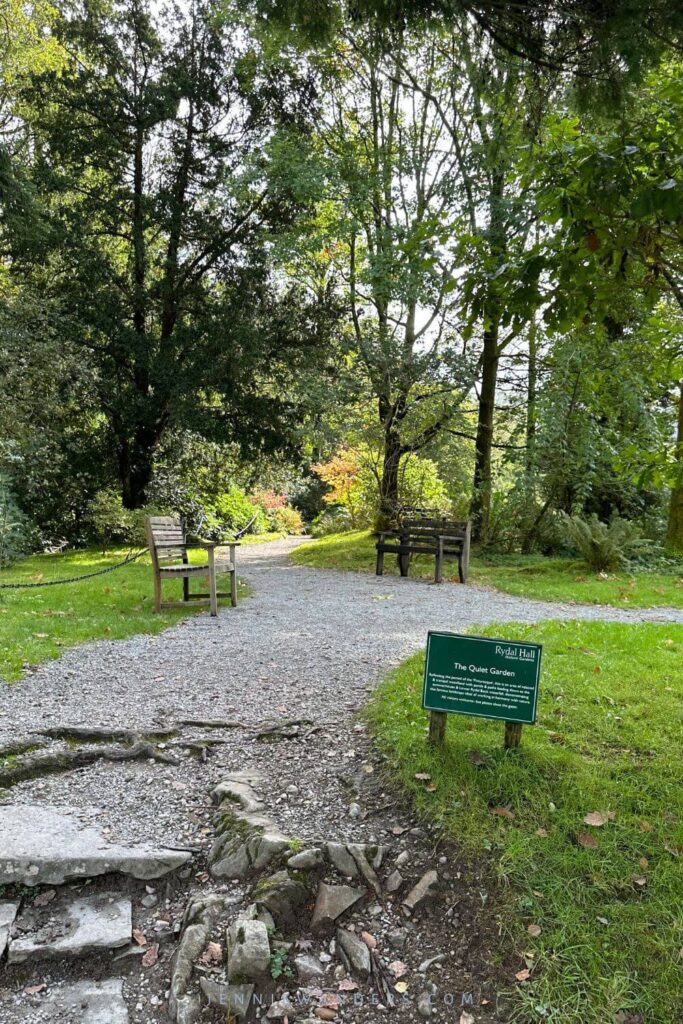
[[470, 321, 499, 544]]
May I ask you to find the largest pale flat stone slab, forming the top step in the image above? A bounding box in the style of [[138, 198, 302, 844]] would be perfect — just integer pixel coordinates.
[[0, 804, 191, 886]]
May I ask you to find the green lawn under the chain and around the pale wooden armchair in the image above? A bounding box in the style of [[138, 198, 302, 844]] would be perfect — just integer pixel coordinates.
[[0, 549, 246, 680]]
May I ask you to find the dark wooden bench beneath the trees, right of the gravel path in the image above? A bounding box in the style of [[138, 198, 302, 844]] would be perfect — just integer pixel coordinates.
[[376, 516, 471, 583]]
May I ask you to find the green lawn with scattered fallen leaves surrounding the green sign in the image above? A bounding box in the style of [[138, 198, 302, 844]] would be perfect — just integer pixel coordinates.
[[370, 622, 683, 1024]]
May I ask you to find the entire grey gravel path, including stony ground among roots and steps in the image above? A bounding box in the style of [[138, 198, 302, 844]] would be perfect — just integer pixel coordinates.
[[0, 540, 683, 1024]]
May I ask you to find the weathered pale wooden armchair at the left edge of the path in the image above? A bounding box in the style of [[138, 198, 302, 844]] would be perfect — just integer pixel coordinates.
[[144, 515, 239, 615]]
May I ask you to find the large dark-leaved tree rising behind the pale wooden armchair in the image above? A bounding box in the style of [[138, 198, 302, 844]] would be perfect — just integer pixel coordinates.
[[14, 0, 325, 507]]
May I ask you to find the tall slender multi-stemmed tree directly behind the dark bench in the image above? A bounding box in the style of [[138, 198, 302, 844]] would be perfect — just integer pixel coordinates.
[[324, 31, 476, 518]]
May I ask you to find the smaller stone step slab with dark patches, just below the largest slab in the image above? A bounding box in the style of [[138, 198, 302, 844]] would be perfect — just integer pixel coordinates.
[[7, 893, 133, 964]]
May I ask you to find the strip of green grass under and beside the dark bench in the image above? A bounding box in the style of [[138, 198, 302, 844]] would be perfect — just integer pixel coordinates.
[[291, 530, 683, 608]]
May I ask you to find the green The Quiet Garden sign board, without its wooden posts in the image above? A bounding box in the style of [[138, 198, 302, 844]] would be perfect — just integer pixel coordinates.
[[422, 632, 542, 725]]
